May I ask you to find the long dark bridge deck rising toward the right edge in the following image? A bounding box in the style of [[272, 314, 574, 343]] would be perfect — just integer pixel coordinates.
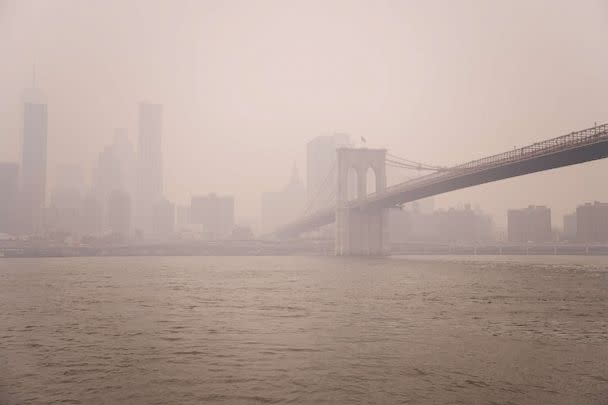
[[275, 124, 608, 254]]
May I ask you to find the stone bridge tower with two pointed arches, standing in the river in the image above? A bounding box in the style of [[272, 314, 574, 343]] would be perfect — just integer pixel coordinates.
[[336, 148, 388, 256]]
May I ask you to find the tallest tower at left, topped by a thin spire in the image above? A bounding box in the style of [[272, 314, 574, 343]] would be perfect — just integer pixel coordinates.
[[20, 97, 47, 234]]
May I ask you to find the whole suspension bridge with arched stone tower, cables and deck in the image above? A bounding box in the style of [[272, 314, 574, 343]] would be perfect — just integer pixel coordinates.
[[274, 124, 608, 255]]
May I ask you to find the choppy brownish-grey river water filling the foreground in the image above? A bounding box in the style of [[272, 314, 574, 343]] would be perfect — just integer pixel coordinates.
[[0, 257, 608, 404]]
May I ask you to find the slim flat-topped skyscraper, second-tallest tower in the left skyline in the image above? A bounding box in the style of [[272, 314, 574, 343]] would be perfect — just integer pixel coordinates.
[[136, 103, 163, 235]]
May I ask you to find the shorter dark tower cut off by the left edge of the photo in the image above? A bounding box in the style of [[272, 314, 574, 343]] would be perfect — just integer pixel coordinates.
[[0, 162, 19, 234]]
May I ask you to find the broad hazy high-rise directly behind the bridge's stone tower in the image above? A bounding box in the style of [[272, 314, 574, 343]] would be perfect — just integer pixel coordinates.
[[306, 134, 353, 211]]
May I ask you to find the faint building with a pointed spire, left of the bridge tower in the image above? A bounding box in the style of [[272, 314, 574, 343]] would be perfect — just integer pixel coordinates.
[[262, 166, 306, 233]]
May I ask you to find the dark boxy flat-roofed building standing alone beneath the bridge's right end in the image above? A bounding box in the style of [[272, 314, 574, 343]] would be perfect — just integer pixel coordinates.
[[507, 205, 553, 243]]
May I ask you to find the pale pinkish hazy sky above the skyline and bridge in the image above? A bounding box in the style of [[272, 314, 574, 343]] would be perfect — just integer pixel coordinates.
[[0, 0, 608, 225]]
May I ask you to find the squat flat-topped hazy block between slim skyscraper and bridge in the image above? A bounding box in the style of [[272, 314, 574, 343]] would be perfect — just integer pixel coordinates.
[[190, 194, 234, 239]]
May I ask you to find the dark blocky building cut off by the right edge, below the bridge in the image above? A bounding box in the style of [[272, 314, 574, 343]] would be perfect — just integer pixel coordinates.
[[576, 201, 608, 243]]
